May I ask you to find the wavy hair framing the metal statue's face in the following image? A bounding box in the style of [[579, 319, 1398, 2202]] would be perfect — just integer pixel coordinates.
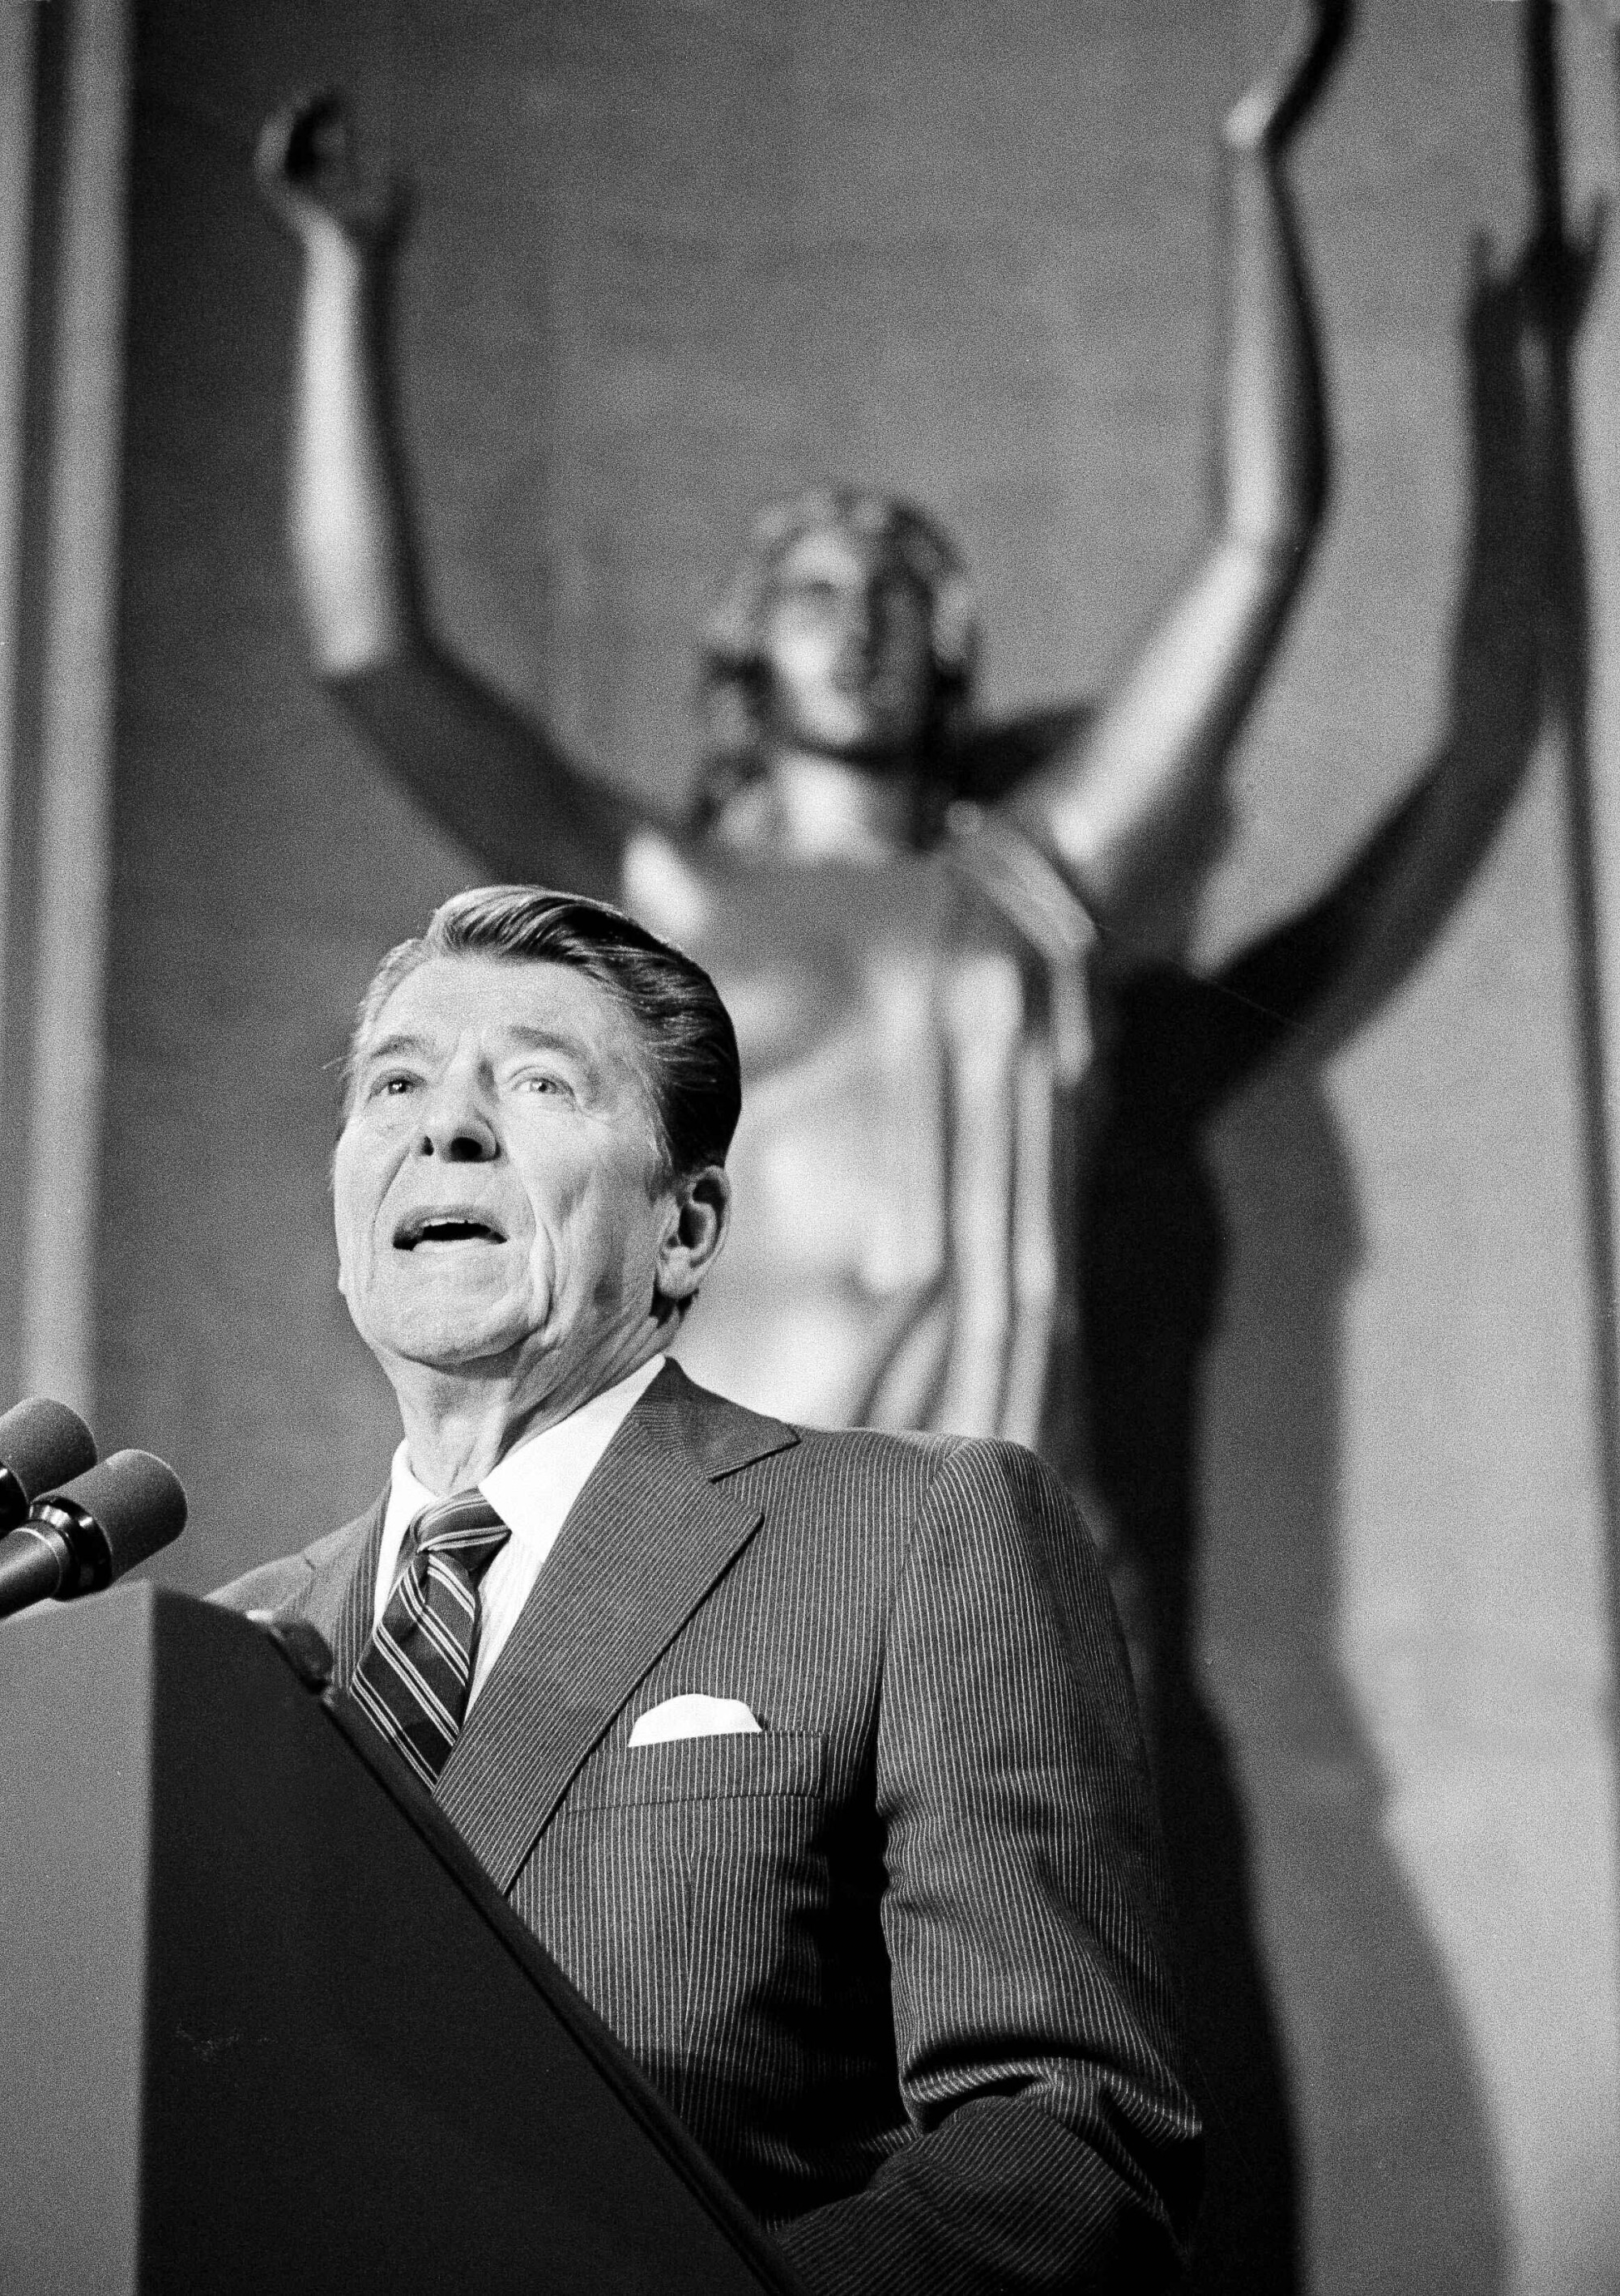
[[694, 487, 979, 827]]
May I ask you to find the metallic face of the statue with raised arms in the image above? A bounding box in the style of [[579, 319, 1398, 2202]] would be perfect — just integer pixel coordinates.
[[765, 526, 933, 765]]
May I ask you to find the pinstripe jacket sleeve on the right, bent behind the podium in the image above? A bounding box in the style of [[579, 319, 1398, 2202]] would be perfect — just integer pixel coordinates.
[[777, 1442, 1200, 2296]]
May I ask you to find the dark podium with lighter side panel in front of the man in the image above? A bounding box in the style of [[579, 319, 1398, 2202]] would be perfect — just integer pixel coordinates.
[[0, 1587, 797, 2296]]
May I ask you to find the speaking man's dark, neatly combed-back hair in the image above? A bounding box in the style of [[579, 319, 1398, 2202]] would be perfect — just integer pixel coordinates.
[[343, 884, 742, 1182]]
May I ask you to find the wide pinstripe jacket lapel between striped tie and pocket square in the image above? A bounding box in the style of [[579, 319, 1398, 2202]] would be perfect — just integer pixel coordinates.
[[439, 1366, 797, 1889]]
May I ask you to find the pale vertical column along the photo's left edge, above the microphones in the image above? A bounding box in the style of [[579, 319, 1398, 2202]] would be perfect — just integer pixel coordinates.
[[0, 0, 129, 1410]]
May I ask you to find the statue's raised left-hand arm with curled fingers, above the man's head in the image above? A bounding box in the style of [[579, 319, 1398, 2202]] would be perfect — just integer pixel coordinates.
[[255, 94, 637, 893]]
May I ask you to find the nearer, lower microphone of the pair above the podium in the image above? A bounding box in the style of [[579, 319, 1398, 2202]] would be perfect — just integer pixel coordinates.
[[0, 1451, 186, 1619]]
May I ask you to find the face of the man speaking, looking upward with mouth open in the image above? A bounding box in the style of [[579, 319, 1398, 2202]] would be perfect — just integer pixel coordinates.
[[333, 957, 678, 1400]]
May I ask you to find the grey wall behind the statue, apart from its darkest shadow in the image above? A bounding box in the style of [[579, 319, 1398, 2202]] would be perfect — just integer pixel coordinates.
[[12, 0, 1620, 2296]]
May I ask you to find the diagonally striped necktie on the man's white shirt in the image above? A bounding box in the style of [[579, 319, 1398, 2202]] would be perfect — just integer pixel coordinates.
[[349, 1490, 513, 1787]]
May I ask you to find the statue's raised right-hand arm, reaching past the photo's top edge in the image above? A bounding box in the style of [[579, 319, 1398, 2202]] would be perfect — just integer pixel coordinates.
[[1013, 0, 1351, 932]]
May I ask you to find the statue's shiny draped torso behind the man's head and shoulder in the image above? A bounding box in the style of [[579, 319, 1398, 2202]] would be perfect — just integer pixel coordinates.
[[627, 824, 1087, 1454]]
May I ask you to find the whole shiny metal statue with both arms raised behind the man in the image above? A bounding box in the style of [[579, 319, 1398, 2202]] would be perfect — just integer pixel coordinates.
[[260, 0, 1349, 1506]]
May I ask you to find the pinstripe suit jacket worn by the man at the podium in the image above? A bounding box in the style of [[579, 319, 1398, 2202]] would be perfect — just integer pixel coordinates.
[[220, 1366, 1197, 2296]]
